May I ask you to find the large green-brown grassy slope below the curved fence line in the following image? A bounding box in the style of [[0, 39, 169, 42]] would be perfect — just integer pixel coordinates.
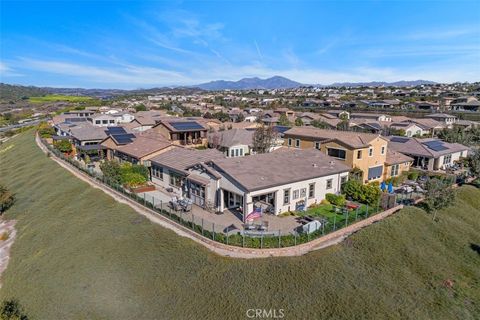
[[0, 132, 480, 319]]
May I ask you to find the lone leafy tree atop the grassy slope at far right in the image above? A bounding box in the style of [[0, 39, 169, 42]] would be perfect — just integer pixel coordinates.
[[423, 178, 455, 220]]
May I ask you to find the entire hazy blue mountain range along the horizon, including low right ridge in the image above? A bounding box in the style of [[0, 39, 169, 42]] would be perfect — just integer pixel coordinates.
[[193, 76, 435, 90]]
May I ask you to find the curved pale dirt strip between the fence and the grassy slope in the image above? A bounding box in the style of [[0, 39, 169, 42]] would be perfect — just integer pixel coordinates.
[[35, 135, 403, 259]]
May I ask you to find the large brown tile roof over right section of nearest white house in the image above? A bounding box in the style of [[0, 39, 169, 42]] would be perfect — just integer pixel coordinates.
[[213, 149, 350, 191]]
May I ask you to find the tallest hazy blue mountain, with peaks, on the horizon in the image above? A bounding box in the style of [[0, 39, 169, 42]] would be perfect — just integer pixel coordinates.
[[195, 76, 303, 90]]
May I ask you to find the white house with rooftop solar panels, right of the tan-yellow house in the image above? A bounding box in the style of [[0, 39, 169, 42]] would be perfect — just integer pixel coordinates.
[[388, 136, 469, 171]]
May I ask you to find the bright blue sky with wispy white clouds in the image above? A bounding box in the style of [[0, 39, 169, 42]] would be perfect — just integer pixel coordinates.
[[0, 0, 480, 88]]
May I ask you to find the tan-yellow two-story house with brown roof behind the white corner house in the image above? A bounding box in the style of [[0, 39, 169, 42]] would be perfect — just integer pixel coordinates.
[[284, 127, 388, 182]]
